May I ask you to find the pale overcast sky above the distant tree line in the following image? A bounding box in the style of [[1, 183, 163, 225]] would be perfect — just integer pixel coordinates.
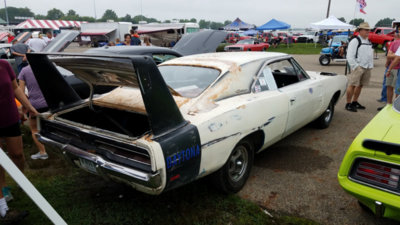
[[0, 0, 400, 28]]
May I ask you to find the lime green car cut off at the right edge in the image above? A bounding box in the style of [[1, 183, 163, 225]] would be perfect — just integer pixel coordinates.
[[338, 97, 400, 221]]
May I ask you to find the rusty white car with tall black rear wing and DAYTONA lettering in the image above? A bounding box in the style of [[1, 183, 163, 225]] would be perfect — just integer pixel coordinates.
[[28, 52, 347, 194]]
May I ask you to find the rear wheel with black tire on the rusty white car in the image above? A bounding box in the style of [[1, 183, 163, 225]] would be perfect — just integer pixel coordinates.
[[212, 140, 254, 194]]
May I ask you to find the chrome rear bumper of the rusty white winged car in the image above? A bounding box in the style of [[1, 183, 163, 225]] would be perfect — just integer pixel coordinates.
[[36, 134, 162, 194]]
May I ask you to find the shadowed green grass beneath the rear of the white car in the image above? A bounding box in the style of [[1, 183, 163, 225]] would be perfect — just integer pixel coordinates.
[[3, 128, 317, 225]]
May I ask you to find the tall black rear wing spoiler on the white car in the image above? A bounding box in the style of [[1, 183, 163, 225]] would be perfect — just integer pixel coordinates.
[[27, 53, 188, 137]]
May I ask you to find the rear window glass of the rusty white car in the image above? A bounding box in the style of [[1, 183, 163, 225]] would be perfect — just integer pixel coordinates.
[[158, 66, 220, 98]]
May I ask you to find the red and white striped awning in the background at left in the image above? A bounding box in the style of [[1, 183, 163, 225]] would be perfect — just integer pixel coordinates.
[[16, 19, 86, 30]]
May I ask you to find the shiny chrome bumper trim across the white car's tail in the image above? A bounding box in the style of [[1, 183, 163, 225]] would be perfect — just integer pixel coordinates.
[[36, 133, 162, 188]]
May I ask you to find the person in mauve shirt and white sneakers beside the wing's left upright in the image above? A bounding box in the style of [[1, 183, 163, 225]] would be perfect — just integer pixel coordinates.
[[18, 66, 49, 159]]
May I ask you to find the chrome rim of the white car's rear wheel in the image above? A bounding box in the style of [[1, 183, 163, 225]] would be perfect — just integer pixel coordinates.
[[228, 145, 249, 182]]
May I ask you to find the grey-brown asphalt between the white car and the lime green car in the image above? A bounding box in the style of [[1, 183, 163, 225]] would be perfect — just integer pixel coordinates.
[[239, 54, 398, 225]]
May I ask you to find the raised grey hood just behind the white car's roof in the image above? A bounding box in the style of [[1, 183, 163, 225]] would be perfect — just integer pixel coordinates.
[[172, 30, 227, 56]]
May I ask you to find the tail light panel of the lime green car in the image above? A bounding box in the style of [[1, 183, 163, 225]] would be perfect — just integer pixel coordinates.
[[350, 159, 400, 193]]
